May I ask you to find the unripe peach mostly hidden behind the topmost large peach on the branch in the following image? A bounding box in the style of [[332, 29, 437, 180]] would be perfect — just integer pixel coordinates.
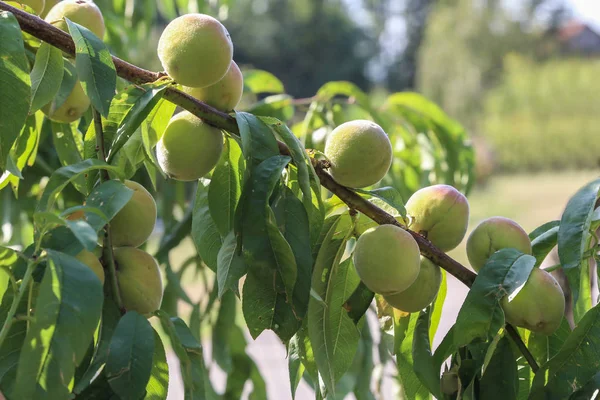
[[183, 61, 244, 111]]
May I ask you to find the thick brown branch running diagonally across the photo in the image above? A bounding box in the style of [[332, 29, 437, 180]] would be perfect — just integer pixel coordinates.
[[0, 1, 538, 370]]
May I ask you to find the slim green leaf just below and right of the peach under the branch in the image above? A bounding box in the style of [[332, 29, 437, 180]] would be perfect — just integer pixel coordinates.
[[192, 181, 223, 272]]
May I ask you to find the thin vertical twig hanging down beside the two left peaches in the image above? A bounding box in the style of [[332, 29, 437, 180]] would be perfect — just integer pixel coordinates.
[[92, 107, 127, 314]]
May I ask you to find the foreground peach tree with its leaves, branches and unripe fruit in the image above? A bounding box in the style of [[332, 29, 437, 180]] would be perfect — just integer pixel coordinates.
[[0, 0, 600, 399]]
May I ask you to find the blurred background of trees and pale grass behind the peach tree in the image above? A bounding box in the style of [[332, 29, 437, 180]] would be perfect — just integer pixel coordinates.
[[81, 0, 600, 399]]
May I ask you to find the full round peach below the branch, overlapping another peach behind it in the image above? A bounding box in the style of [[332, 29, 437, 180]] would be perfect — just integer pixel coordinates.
[[354, 225, 420, 295]]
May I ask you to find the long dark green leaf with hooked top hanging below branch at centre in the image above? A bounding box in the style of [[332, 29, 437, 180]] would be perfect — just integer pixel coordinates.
[[238, 156, 299, 341]]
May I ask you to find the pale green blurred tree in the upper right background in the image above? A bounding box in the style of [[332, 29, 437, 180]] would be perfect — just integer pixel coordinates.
[[417, 0, 564, 129]]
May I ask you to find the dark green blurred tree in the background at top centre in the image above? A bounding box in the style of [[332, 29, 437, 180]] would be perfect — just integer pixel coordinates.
[[225, 0, 379, 97]]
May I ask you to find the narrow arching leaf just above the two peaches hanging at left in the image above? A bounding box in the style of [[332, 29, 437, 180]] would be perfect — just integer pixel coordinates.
[[36, 159, 120, 211]]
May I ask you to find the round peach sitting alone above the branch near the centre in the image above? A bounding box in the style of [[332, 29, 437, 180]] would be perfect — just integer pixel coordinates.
[[325, 120, 392, 188]]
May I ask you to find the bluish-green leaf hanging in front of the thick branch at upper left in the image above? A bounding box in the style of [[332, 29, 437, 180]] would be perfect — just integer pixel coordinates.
[[65, 18, 117, 117]]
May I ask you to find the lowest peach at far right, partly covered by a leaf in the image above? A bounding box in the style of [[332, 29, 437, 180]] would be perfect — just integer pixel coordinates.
[[501, 268, 565, 335]]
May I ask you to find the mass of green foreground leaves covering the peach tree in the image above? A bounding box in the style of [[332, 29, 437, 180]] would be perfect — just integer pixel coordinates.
[[0, 3, 600, 399]]
